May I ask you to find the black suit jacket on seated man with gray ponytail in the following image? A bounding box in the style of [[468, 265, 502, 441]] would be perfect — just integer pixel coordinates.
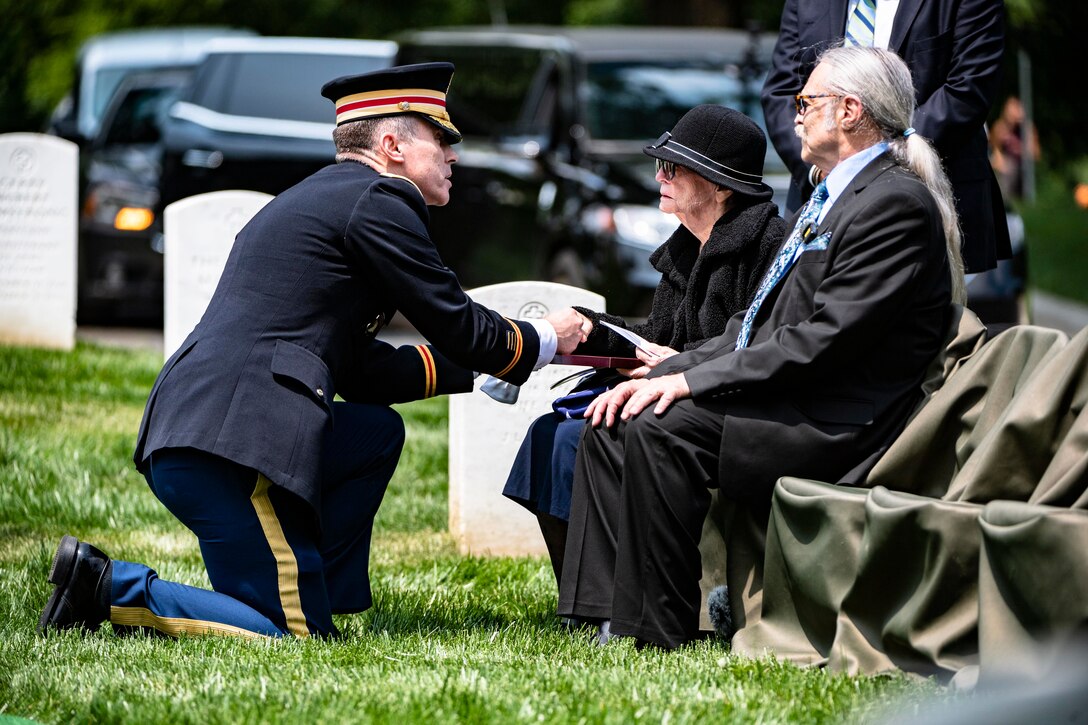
[[652, 155, 952, 502]]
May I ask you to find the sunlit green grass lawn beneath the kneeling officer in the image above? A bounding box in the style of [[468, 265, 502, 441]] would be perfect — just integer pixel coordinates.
[[0, 345, 953, 724]]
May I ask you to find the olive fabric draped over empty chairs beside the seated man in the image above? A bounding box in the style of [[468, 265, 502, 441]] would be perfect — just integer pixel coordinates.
[[727, 325, 1088, 684]]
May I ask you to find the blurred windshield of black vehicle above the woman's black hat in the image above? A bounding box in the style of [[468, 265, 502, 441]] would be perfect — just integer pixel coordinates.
[[586, 62, 763, 140]]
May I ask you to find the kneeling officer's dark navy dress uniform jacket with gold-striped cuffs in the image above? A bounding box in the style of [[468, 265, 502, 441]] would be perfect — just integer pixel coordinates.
[[134, 162, 540, 509]]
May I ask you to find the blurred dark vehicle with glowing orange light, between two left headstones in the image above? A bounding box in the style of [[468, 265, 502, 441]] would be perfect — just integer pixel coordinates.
[[77, 70, 191, 324]]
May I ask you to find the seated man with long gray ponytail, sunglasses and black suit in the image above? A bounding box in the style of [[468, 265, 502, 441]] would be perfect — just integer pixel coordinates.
[[559, 47, 964, 648]]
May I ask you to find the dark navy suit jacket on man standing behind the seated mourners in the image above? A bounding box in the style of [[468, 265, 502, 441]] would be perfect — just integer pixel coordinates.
[[763, 0, 1012, 272]]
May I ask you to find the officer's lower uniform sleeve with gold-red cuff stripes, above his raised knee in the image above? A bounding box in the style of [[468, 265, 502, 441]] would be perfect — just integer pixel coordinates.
[[339, 340, 472, 405]]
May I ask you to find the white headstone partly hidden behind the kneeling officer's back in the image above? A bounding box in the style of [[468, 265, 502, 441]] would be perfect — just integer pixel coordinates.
[[163, 192, 272, 358]]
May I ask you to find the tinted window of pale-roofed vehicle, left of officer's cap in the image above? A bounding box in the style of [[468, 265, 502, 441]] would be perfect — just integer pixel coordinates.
[[211, 53, 387, 123]]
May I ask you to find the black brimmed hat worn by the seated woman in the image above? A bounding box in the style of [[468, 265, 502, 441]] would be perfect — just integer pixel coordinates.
[[643, 105, 772, 200]]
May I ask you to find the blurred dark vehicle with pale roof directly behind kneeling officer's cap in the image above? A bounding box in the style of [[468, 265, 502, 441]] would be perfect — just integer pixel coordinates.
[[160, 37, 396, 207]]
